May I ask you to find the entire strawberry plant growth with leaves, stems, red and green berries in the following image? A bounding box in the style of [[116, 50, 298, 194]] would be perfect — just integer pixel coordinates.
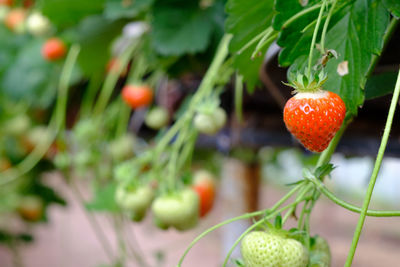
[[0, 0, 400, 267]]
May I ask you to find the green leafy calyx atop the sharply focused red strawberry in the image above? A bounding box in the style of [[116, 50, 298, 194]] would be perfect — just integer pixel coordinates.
[[284, 71, 328, 94]]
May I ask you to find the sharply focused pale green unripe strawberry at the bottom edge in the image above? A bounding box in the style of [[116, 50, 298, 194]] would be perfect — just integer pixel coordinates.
[[241, 231, 308, 267]]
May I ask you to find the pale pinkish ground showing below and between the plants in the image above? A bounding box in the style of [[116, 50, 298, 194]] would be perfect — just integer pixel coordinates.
[[0, 174, 400, 267]]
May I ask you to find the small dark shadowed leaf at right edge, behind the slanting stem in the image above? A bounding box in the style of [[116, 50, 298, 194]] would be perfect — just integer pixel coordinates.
[[365, 72, 397, 99]]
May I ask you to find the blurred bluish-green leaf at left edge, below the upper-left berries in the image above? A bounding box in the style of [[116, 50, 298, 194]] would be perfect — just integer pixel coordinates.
[[1, 40, 60, 108]]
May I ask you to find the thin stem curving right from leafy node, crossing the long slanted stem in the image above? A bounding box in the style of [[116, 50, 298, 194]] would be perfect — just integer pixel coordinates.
[[309, 179, 400, 217]]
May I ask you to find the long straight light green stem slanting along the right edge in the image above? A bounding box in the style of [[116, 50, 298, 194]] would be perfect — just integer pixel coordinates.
[[345, 67, 400, 267]]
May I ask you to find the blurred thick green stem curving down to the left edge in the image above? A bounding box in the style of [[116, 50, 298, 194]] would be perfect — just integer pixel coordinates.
[[0, 45, 80, 186]]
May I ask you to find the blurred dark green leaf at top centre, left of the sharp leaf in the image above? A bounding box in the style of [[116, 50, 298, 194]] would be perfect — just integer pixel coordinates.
[[152, 0, 214, 56]]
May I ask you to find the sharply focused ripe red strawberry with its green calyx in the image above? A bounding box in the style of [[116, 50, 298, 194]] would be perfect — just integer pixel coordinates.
[[283, 73, 346, 152]]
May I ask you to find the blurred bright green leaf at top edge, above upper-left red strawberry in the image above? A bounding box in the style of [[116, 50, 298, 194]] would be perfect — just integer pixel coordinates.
[[40, 0, 105, 27]]
